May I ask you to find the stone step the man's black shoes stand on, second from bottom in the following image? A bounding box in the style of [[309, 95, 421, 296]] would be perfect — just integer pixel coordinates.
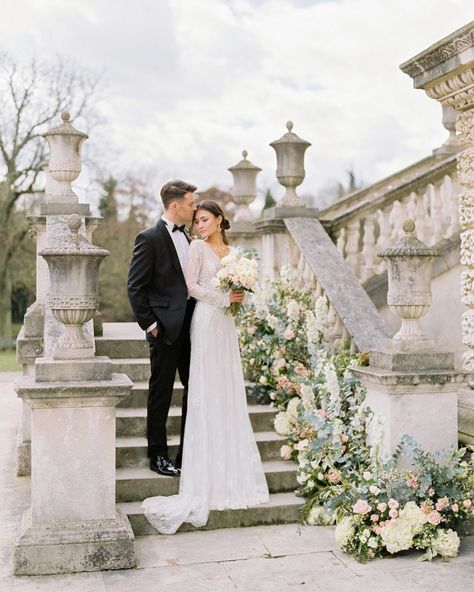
[[116, 460, 298, 502]]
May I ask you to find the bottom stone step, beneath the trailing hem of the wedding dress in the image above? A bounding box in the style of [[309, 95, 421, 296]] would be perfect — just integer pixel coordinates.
[[119, 492, 303, 536]]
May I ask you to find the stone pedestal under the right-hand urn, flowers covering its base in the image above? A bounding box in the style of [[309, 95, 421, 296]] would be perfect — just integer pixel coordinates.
[[353, 350, 466, 462]]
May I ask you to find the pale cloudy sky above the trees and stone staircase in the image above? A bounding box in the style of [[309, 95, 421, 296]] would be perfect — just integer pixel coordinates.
[[0, 0, 474, 205]]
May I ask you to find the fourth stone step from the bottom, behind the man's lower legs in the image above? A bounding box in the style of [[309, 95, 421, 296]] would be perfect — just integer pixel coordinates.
[[116, 405, 276, 437]]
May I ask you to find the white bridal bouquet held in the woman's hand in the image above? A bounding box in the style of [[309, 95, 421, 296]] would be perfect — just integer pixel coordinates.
[[213, 248, 258, 316]]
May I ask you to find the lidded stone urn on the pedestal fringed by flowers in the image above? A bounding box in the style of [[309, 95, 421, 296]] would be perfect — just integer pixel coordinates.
[[378, 218, 438, 349]]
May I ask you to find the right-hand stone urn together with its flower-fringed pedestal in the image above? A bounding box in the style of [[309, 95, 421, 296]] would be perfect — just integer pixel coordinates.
[[353, 220, 466, 463]]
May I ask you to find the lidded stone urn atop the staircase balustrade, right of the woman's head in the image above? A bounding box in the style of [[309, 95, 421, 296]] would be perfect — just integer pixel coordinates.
[[270, 121, 311, 206]]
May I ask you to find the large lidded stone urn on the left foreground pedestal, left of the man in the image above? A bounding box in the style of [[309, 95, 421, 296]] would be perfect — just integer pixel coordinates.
[[39, 214, 109, 360]]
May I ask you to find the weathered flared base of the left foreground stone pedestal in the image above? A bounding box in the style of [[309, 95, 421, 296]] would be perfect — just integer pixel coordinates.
[[14, 508, 136, 575]]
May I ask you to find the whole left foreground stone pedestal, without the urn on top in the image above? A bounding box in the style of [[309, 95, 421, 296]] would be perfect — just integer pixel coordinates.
[[14, 357, 135, 575]]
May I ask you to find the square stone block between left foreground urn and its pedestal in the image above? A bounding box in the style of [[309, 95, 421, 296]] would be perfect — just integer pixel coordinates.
[[35, 356, 113, 382]]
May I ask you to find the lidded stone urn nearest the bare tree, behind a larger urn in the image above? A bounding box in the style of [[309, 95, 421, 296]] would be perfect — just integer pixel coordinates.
[[43, 112, 89, 203]]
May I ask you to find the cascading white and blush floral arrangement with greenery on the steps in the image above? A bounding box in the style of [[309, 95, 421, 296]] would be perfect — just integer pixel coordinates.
[[240, 274, 474, 561]]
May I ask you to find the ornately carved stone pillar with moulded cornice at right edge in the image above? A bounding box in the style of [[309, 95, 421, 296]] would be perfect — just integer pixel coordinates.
[[400, 21, 474, 442]]
